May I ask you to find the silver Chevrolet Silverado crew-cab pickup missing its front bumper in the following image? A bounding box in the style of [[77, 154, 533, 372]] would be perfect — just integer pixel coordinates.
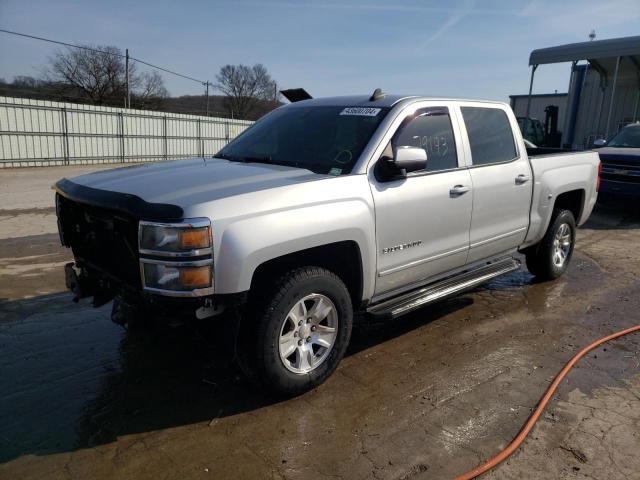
[[55, 91, 600, 395]]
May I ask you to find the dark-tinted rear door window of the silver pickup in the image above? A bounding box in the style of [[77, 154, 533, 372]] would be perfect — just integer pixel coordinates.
[[461, 107, 518, 165]]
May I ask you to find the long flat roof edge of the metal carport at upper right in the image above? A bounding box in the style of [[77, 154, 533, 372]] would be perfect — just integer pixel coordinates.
[[529, 35, 640, 65]]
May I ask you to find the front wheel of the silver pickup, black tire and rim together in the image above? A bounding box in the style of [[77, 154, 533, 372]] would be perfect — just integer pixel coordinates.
[[238, 266, 353, 397]]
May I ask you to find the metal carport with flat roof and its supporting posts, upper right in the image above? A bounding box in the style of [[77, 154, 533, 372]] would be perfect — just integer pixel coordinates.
[[527, 36, 640, 142]]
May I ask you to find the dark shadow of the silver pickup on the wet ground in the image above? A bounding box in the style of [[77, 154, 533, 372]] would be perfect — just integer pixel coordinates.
[[0, 293, 473, 462]]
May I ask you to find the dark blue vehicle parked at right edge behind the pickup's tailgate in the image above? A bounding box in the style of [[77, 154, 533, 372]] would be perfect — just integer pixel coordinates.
[[593, 122, 640, 197]]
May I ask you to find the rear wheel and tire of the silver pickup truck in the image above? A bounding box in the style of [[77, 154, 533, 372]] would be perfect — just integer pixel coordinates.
[[525, 209, 576, 280]]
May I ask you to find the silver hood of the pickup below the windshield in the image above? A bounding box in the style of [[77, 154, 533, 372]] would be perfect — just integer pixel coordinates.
[[55, 158, 331, 213]]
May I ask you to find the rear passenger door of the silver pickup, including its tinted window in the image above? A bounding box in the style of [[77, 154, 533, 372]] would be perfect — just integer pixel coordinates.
[[460, 103, 533, 263]]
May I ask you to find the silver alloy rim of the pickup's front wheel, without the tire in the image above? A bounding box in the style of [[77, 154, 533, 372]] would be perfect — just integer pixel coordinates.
[[279, 293, 338, 375]]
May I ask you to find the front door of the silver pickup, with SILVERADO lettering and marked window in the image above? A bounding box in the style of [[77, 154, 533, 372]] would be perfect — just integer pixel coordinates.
[[370, 107, 472, 295]]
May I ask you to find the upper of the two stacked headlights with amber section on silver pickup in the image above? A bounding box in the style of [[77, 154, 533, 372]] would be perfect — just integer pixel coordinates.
[[139, 220, 211, 256]]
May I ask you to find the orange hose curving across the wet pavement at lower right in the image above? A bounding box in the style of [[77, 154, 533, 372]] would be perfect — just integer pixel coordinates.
[[454, 325, 640, 480]]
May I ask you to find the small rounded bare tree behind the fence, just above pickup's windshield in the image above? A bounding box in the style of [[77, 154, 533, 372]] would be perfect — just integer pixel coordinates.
[[216, 63, 277, 118]]
